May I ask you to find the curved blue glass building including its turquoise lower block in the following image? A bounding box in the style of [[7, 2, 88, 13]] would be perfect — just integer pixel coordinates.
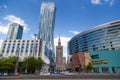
[[68, 20, 120, 73]]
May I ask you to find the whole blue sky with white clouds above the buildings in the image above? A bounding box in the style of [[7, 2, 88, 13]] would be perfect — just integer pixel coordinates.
[[0, 0, 120, 56]]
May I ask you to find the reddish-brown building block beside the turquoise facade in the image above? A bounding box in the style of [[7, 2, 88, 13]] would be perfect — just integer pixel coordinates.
[[71, 53, 91, 72]]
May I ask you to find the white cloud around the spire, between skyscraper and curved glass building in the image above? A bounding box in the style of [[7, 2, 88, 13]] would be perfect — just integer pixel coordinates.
[[54, 36, 71, 57]]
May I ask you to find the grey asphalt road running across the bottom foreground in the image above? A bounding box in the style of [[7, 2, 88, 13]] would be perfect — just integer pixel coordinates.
[[0, 74, 120, 80]]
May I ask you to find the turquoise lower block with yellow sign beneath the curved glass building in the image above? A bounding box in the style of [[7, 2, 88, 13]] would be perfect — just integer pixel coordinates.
[[90, 50, 120, 74]]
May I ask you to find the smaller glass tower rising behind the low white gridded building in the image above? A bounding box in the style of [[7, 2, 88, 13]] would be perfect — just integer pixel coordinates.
[[6, 23, 23, 39]]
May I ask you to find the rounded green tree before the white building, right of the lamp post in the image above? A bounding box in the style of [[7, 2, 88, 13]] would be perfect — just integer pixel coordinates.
[[22, 57, 44, 73]]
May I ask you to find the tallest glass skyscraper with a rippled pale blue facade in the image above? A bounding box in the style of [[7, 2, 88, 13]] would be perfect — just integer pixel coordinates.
[[38, 2, 55, 67]]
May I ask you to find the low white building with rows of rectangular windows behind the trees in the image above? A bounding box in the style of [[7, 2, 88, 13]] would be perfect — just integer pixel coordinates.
[[0, 39, 50, 64]]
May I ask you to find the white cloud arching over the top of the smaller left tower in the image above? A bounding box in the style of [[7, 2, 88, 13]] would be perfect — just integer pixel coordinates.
[[4, 15, 30, 33]]
